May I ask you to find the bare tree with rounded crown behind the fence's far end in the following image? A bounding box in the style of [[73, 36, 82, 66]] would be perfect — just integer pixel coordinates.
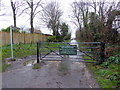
[[41, 2, 62, 36]]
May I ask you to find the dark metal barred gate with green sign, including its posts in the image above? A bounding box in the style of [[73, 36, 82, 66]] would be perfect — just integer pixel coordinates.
[[37, 40, 105, 64]]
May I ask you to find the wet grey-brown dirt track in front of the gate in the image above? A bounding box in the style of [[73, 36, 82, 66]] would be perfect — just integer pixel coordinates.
[[2, 56, 99, 88]]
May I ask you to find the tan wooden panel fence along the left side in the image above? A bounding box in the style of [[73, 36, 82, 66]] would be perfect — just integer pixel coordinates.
[[0, 32, 48, 46]]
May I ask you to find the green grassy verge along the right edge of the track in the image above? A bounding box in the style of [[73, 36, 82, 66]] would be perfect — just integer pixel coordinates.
[[83, 56, 120, 88]]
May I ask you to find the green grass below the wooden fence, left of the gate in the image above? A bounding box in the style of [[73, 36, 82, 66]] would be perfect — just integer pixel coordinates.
[[0, 44, 36, 71]]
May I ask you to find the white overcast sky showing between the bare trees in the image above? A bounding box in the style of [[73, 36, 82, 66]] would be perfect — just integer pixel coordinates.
[[0, 0, 119, 37]]
